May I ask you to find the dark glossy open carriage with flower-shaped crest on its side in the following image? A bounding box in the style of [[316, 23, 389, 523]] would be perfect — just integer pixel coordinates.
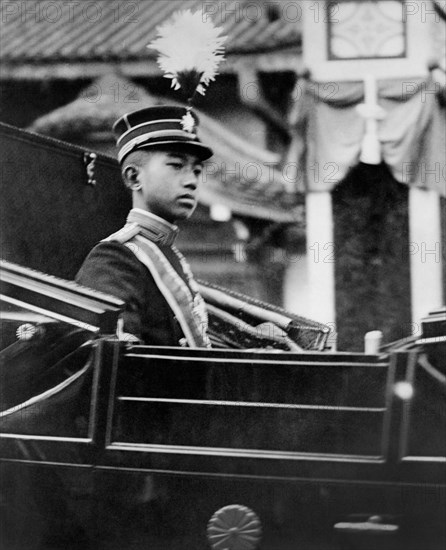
[[0, 125, 446, 550]]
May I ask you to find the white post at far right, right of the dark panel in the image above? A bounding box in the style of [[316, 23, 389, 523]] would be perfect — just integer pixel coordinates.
[[409, 187, 443, 334]]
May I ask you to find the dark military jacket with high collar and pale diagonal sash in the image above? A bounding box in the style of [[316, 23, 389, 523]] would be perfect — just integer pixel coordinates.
[[76, 208, 209, 347]]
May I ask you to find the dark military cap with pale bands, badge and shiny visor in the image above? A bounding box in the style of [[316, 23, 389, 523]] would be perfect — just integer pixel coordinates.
[[113, 105, 213, 162]]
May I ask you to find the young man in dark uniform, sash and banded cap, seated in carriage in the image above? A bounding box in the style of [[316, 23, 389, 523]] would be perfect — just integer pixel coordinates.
[[76, 106, 212, 347]]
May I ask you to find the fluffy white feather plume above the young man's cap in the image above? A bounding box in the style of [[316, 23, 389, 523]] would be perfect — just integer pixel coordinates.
[[147, 10, 227, 99]]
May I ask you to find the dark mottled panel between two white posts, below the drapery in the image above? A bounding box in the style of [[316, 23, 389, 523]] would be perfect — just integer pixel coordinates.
[[333, 164, 411, 351]]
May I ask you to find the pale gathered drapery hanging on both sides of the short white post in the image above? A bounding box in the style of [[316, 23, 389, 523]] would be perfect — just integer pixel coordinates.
[[300, 77, 446, 196]]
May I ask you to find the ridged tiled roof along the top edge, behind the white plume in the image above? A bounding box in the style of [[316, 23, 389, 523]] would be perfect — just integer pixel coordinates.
[[0, 0, 301, 64]]
